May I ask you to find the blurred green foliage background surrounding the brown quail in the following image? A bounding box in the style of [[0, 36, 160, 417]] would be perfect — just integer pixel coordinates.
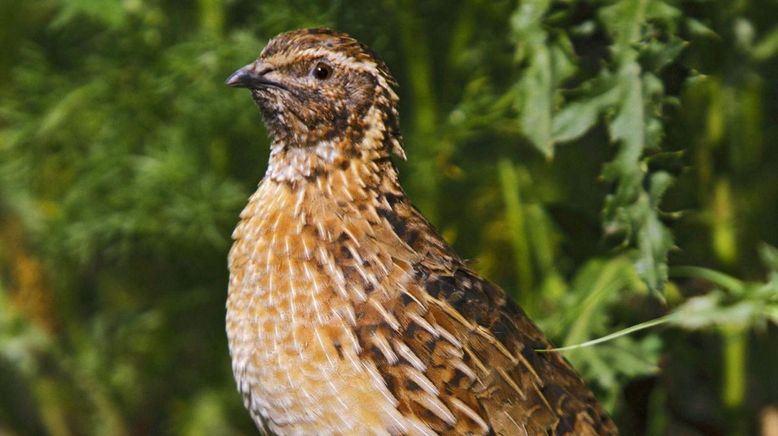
[[0, 0, 778, 435]]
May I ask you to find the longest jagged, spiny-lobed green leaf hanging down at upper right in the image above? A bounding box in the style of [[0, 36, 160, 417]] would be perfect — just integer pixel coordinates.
[[600, 0, 682, 296]]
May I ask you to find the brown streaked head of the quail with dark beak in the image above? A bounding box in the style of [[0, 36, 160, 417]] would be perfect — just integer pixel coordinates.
[[227, 29, 404, 157]]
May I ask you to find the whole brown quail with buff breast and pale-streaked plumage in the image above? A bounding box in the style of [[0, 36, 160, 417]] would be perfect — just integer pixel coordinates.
[[227, 29, 616, 435]]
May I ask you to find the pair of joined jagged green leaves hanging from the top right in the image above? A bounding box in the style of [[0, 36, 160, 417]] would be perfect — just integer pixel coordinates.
[[512, 0, 684, 292]]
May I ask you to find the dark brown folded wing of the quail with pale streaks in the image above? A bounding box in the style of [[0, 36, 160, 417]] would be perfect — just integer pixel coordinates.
[[359, 198, 617, 435]]
